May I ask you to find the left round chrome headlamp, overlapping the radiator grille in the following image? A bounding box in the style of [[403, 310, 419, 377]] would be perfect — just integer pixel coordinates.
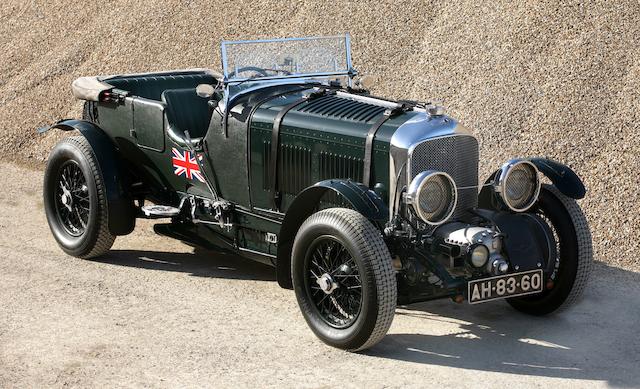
[[405, 170, 458, 225]]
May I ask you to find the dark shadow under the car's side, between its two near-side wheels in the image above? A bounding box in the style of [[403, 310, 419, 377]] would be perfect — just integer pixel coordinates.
[[91, 248, 276, 281]]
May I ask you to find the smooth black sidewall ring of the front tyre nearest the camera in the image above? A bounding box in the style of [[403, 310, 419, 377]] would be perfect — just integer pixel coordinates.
[[292, 214, 378, 350]]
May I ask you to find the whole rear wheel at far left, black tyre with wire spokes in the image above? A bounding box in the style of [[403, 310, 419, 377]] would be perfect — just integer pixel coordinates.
[[44, 136, 115, 258]]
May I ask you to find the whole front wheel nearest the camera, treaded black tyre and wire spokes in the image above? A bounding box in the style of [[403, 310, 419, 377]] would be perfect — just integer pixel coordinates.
[[291, 208, 397, 351]]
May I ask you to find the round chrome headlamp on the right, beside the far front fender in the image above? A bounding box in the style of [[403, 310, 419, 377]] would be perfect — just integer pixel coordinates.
[[495, 159, 541, 212]]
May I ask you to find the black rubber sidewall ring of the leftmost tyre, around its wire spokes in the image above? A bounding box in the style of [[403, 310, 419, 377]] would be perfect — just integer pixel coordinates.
[[43, 138, 106, 257]]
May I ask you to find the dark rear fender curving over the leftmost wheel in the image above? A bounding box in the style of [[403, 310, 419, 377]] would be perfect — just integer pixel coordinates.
[[48, 119, 136, 235]]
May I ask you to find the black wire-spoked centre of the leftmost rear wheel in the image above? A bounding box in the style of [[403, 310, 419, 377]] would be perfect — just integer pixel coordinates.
[[55, 161, 91, 236]]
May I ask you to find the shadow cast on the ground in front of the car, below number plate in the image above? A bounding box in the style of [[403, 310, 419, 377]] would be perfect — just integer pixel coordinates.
[[365, 264, 640, 387]]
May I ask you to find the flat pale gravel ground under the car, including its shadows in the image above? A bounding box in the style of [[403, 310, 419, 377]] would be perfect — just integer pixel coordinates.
[[0, 163, 640, 389]]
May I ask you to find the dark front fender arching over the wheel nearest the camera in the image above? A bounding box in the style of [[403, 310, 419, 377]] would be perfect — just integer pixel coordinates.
[[276, 180, 389, 289]]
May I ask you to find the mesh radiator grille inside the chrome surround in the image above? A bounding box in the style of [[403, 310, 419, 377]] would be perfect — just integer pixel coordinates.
[[410, 136, 479, 218]]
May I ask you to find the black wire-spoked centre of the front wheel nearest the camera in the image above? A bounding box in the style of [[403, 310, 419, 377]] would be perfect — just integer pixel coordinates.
[[305, 236, 362, 328]]
